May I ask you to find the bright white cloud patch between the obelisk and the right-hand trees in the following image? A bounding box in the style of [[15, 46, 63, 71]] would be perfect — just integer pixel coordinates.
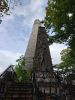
[[49, 43, 67, 64]]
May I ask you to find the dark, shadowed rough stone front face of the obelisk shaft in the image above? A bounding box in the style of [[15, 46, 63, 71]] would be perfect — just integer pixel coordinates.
[[34, 26, 52, 71]]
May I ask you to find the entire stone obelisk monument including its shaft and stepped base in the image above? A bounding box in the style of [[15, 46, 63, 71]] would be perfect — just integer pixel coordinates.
[[25, 20, 60, 100]]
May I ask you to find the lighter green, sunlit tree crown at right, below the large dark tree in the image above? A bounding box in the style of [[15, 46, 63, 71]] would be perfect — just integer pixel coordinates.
[[59, 48, 75, 70]]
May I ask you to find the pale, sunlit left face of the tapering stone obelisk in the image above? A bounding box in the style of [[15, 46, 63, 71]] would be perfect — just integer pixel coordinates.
[[25, 20, 41, 68]]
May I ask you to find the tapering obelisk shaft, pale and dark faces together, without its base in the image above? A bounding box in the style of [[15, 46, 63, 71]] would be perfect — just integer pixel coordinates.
[[25, 19, 52, 70]]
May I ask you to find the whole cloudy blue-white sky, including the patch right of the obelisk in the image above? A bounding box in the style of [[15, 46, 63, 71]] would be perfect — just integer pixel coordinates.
[[0, 0, 66, 72]]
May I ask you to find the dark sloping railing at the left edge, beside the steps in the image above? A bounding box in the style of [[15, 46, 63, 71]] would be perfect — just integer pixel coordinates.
[[0, 65, 16, 100]]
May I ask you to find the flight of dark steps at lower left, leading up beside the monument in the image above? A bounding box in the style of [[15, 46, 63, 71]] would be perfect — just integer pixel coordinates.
[[3, 83, 33, 100]]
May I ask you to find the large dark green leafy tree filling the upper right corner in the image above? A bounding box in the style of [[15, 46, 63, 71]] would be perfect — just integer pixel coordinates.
[[44, 0, 75, 58]]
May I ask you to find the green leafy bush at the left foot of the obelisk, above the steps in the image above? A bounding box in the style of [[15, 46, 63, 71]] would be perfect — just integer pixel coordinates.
[[15, 56, 32, 82]]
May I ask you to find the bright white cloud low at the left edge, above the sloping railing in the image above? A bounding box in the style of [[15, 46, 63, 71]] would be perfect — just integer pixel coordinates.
[[0, 50, 21, 73]]
